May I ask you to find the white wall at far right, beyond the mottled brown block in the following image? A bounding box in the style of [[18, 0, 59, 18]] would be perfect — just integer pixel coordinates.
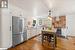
[[67, 13, 75, 36]]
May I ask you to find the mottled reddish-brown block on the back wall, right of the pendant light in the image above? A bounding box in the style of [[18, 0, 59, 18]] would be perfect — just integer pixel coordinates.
[[52, 16, 66, 28]]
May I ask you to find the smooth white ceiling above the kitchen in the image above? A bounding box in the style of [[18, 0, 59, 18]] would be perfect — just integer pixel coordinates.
[[10, 0, 75, 16]]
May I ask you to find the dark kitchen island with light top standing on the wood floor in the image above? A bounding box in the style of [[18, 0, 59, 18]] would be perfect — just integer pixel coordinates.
[[42, 30, 57, 48]]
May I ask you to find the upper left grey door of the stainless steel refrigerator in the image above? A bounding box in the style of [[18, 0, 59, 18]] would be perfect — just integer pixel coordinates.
[[12, 16, 19, 34]]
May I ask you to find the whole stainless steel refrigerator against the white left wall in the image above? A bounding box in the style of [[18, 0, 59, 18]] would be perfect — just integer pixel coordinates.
[[12, 16, 27, 46]]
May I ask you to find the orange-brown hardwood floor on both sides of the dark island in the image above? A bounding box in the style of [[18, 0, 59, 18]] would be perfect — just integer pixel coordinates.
[[8, 36, 75, 50]]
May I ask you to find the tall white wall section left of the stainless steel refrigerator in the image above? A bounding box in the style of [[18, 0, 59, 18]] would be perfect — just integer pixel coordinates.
[[0, 8, 11, 48]]
